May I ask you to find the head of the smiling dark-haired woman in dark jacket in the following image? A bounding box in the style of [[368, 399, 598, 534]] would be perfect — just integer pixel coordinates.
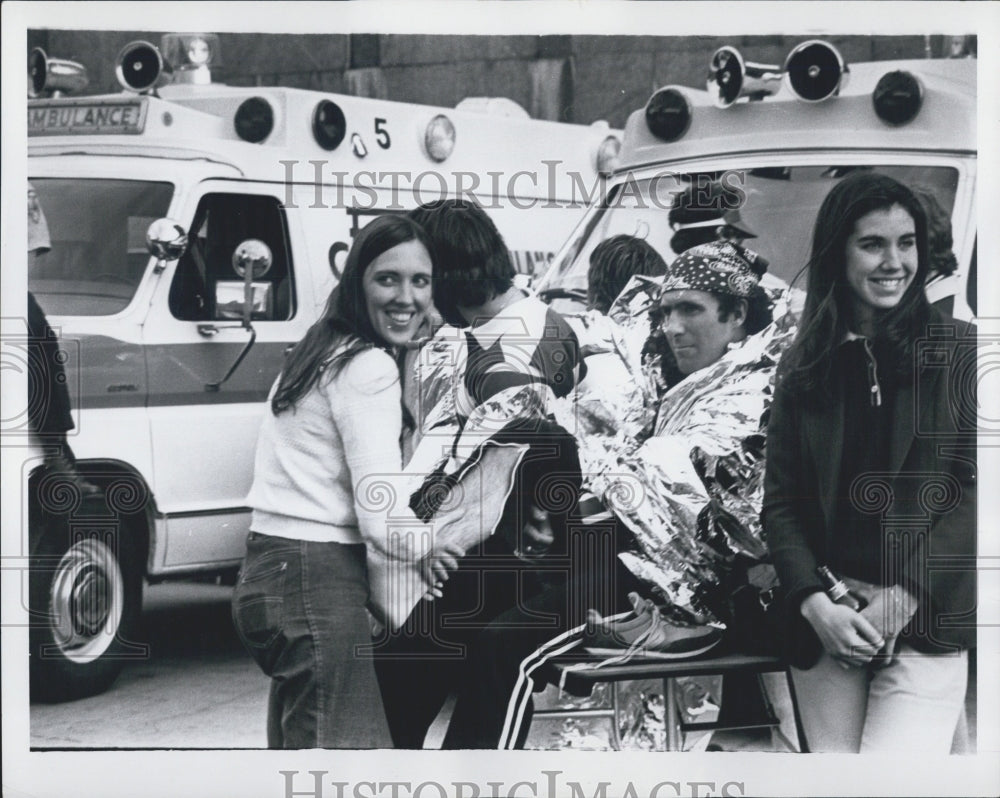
[[803, 171, 928, 335]]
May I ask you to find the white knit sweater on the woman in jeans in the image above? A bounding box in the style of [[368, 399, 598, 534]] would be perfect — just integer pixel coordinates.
[[248, 349, 402, 548]]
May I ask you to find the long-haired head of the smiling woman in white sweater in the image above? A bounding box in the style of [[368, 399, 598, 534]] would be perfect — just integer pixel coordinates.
[[271, 215, 433, 414]]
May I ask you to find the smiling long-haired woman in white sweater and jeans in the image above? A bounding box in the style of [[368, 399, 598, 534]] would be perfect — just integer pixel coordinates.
[[233, 216, 458, 748]]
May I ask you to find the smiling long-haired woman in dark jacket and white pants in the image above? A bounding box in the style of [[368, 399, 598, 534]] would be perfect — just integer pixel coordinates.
[[763, 171, 976, 753]]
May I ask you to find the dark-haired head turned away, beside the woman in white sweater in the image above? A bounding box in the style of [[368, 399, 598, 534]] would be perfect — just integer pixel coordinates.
[[409, 199, 515, 327]]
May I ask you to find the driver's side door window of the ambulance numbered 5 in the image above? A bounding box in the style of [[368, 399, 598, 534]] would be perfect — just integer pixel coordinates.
[[169, 194, 295, 321]]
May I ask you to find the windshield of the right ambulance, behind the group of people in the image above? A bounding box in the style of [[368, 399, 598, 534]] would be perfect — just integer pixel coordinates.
[[536, 165, 958, 313]]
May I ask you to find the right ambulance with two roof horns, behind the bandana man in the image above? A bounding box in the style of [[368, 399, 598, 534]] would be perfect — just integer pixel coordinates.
[[537, 40, 977, 319]]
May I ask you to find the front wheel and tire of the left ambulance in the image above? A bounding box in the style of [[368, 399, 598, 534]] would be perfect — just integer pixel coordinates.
[[28, 490, 144, 702]]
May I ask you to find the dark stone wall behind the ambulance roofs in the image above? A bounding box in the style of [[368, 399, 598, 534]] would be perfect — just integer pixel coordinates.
[[28, 30, 968, 127]]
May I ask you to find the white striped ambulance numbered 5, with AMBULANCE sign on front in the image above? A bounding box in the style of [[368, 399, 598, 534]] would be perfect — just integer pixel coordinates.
[[21, 34, 620, 700]]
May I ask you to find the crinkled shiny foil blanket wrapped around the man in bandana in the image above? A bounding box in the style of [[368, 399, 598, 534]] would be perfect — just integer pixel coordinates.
[[554, 278, 796, 625]]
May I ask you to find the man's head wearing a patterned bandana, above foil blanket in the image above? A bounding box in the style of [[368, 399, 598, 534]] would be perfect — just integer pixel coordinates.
[[655, 241, 771, 375]]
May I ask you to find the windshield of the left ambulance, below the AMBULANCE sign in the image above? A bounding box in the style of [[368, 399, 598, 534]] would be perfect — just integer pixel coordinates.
[[28, 178, 174, 316]]
